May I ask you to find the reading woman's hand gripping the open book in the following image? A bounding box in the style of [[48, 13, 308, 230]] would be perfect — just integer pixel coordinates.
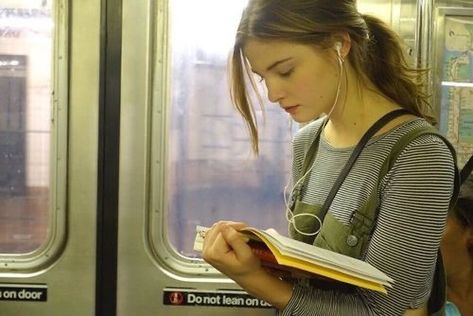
[[202, 221, 262, 282]]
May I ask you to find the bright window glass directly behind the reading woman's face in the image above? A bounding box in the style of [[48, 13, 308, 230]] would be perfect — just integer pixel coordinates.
[[167, 0, 292, 256]]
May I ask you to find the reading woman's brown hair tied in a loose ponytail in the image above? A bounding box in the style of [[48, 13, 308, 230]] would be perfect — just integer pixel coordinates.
[[230, 0, 433, 153]]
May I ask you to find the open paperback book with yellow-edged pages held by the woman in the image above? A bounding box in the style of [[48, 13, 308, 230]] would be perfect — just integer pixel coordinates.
[[194, 226, 393, 293]]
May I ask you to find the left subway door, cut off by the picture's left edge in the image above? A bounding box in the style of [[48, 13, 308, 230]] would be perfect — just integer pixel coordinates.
[[0, 0, 101, 316]]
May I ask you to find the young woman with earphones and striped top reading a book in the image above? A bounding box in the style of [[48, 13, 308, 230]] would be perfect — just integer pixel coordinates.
[[203, 0, 455, 316]]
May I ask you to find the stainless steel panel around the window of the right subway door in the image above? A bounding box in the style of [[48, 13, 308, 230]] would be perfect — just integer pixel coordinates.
[[117, 0, 274, 316]]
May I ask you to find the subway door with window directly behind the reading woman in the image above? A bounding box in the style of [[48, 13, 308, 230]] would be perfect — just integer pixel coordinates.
[[117, 0, 293, 316]]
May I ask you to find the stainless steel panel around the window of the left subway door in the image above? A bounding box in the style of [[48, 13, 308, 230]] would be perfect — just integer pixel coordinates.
[[0, 0, 100, 316]]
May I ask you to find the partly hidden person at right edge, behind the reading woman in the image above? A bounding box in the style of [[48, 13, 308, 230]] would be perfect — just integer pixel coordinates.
[[441, 157, 473, 316]]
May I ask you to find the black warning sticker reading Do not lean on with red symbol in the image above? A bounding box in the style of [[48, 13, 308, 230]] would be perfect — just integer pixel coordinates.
[[163, 288, 272, 308]]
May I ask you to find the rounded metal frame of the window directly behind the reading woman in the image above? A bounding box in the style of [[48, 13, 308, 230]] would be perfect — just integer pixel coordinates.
[[144, 0, 292, 283]]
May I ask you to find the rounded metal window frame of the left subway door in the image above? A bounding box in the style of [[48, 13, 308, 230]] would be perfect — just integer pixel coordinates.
[[0, 0, 69, 277]]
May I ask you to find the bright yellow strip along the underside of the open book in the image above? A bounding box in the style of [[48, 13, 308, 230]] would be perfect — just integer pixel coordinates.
[[249, 232, 387, 294]]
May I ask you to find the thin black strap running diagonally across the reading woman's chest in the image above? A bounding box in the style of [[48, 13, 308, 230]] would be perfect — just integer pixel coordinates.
[[319, 109, 411, 222]]
